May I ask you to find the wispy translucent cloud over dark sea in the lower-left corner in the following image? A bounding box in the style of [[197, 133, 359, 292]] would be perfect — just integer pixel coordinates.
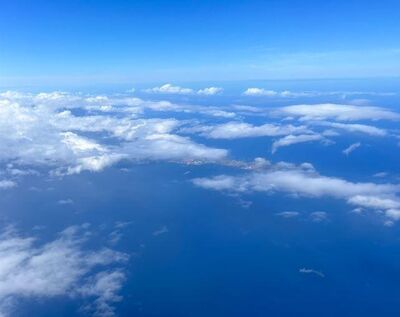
[[0, 225, 127, 316]]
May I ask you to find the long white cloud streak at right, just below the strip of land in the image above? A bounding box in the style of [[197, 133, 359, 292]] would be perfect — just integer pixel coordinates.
[[192, 163, 400, 220]]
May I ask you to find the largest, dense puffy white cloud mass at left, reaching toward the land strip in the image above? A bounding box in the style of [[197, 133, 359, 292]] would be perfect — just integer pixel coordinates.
[[0, 92, 229, 175]]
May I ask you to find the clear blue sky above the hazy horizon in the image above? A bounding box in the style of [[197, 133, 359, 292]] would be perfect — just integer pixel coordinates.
[[0, 0, 400, 85]]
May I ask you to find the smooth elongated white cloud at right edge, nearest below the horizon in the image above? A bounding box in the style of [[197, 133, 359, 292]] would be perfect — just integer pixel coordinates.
[[273, 103, 400, 121]]
